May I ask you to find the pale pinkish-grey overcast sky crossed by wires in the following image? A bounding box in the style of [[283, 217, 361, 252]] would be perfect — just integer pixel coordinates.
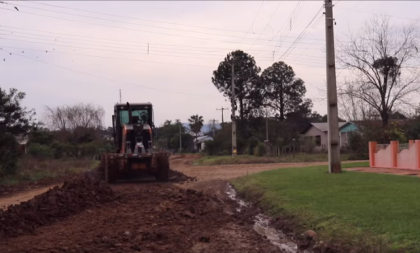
[[0, 0, 420, 125]]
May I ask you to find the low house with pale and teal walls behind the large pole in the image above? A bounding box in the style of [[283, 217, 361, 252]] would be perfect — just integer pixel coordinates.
[[301, 122, 357, 151]]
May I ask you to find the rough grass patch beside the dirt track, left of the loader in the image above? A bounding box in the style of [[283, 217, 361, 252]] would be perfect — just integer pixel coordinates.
[[0, 157, 99, 185]]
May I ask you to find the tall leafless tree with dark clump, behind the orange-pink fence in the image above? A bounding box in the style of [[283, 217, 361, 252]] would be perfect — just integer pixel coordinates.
[[337, 16, 420, 126]]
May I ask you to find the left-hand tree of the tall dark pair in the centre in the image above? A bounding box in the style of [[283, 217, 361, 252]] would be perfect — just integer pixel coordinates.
[[211, 50, 261, 120]]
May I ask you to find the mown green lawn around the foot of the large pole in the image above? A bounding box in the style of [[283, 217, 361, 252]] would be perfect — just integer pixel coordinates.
[[232, 163, 420, 252]]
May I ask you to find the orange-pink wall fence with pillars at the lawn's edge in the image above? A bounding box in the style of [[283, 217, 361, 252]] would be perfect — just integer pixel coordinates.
[[369, 140, 420, 170]]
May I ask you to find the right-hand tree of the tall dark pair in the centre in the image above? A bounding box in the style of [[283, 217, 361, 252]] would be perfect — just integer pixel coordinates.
[[261, 61, 312, 121]]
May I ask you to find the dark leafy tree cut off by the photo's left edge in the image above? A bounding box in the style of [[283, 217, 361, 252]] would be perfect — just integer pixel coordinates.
[[0, 88, 36, 177]]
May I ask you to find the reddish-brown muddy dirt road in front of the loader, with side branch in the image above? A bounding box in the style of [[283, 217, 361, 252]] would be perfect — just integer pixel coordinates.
[[0, 156, 334, 253]]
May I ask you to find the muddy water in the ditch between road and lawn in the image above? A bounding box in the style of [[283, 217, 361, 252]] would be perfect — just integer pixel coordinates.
[[226, 184, 311, 253]]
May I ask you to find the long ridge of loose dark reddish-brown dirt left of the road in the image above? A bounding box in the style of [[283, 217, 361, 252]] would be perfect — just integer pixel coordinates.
[[0, 174, 114, 238]]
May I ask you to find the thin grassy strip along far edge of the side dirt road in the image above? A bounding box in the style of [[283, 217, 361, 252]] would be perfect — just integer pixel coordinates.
[[193, 154, 349, 166]]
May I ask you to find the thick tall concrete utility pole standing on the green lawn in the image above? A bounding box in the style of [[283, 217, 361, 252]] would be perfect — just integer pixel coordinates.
[[325, 0, 341, 173]]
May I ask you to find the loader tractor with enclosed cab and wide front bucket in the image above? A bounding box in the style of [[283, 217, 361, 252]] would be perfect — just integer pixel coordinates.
[[99, 102, 170, 183]]
